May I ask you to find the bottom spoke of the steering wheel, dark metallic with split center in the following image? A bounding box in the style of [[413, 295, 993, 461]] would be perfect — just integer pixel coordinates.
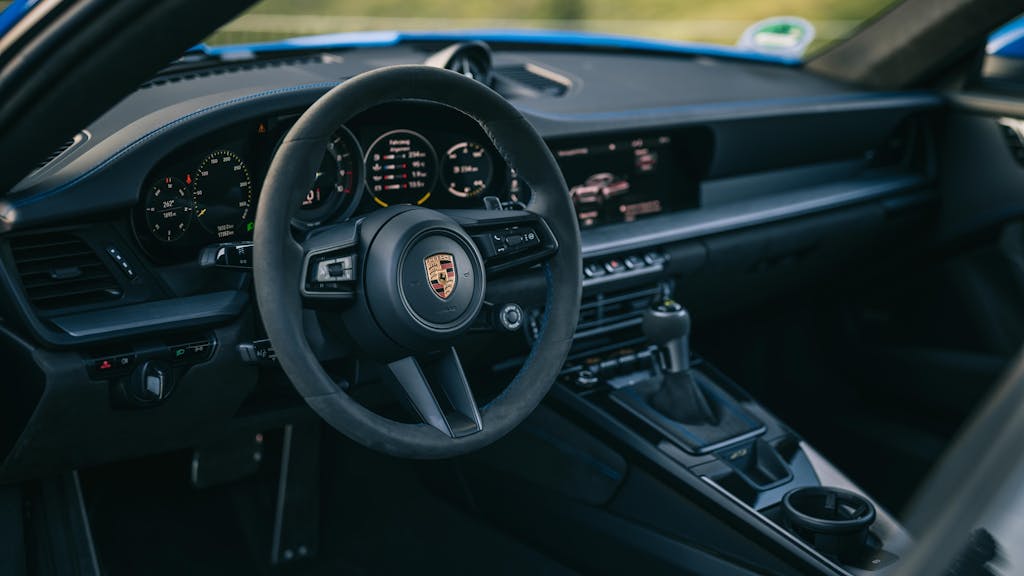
[[387, 347, 483, 438]]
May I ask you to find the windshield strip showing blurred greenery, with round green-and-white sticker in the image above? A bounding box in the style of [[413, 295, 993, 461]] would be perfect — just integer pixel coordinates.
[[197, 0, 893, 58]]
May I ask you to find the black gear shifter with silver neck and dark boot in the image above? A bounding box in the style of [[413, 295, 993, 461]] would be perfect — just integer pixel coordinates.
[[643, 298, 718, 424]]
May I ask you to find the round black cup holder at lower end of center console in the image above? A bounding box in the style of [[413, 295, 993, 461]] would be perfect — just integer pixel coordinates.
[[782, 486, 874, 564]]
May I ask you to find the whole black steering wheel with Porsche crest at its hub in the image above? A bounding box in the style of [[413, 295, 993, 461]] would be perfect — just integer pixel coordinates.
[[253, 66, 582, 458]]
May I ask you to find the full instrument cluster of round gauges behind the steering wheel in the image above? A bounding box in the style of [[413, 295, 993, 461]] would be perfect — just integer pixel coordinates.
[[132, 102, 528, 260]]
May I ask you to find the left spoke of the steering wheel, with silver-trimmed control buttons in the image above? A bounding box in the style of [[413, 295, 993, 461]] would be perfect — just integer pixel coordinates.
[[300, 218, 358, 306]]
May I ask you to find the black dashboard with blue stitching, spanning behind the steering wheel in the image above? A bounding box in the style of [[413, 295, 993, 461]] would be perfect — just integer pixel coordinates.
[[0, 39, 942, 478]]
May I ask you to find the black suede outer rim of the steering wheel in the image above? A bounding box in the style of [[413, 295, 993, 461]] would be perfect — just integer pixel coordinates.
[[253, 66, 583, 458]]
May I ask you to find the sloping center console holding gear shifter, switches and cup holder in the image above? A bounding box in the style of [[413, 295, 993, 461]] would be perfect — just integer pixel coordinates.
[[536, 283, 908, 575]]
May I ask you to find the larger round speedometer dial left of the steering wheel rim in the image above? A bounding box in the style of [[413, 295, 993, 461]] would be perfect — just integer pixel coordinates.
[[193, 150, 253, 238]]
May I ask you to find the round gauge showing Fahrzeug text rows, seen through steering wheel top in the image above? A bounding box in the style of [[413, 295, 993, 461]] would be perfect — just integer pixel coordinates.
[[366, 130, 437, 206]]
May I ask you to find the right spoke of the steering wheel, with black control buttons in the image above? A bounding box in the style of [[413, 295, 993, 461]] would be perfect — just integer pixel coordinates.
[[441, 210, 558, 274]]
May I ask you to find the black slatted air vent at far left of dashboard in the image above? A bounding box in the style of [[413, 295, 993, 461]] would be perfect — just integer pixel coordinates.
[[10, 233, 122, 311]]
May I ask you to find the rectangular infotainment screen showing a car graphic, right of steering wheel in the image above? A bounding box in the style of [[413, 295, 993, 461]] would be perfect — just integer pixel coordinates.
[[554, 135, 682, 229]]
